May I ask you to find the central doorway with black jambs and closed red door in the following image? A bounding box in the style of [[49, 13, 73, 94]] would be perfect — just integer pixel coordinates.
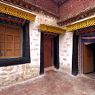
[[40, 32, 59, 74]]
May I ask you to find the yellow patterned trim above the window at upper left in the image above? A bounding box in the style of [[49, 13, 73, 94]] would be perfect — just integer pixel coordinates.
[[0, 2, 36, 21]]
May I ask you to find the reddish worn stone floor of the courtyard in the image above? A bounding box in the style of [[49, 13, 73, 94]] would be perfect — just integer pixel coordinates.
[[0, 71, 95, 95]]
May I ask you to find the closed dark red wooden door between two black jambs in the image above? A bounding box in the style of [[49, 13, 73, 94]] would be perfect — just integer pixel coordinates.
[[44, 35, 54, 68]]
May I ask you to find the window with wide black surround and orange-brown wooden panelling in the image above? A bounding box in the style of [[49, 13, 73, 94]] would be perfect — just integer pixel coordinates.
[[0, 20, 30, 67]]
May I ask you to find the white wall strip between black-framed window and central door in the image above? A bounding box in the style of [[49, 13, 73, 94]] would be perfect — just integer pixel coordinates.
[[29, 22, 41, 69]]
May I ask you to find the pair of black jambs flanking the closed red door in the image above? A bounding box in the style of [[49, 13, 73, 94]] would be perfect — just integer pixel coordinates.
[[40, 32, 59, 74]]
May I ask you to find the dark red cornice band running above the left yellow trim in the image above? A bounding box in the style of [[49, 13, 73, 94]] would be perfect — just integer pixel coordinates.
[[2, 0, 59, 19]]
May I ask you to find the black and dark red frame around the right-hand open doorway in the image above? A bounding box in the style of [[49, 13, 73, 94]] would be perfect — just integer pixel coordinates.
[[72, 26, 95, 75]]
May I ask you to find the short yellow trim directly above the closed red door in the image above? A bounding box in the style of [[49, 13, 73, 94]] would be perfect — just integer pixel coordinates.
[[39, 24, 66, 34]]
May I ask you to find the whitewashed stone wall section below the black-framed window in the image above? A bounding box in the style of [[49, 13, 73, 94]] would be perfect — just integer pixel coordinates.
[[0, 64, 39, 87]]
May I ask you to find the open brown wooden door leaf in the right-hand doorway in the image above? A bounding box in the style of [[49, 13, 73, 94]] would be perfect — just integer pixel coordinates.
[[83, 45, 94, 73]]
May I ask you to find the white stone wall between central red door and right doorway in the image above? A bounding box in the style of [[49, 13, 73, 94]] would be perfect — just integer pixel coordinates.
[[59, 32, 73, 74]]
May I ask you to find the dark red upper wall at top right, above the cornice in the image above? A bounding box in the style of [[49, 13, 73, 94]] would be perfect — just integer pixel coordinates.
[[60, 0, 95, 20]]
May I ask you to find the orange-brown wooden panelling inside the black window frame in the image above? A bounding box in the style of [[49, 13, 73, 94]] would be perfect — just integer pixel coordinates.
[[0, 24, 22, 58]]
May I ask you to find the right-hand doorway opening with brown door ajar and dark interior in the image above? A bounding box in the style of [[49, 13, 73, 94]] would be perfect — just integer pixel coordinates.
[[83, 43, 95, 74]]
